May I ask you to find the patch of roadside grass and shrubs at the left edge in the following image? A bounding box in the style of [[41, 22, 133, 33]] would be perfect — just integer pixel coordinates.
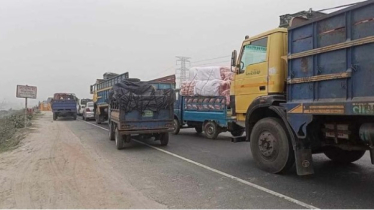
[[0, 111, 41, 152]]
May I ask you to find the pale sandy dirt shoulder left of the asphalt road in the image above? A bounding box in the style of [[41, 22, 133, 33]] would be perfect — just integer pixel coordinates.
[[0, 112, 166, 208]]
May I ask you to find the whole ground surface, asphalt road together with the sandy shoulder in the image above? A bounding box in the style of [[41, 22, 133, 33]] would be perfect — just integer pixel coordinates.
[[0, 113, 374, 208]]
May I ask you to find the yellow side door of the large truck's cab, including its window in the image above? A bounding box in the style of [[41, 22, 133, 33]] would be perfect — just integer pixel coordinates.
[[235, 36, 268, 117]]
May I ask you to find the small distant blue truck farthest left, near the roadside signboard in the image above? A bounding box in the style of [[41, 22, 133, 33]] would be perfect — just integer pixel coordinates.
[[51, 93, 77, 120]]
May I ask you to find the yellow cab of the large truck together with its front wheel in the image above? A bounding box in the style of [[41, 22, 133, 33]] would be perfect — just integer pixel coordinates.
[[230, 28, 300, 174]]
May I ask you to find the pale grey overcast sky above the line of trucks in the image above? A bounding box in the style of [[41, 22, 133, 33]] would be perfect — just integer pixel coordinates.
[[0, 0, 357, 108]]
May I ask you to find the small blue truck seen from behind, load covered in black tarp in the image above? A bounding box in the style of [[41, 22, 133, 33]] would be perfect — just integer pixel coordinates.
[[109, 79, 175, 150]]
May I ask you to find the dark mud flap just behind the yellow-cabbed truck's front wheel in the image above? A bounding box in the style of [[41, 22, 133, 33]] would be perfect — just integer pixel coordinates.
[[295, 148, 314, 176]]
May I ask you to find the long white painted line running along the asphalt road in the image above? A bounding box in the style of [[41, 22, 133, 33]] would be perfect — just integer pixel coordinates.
[[83, 121, 319, 209]]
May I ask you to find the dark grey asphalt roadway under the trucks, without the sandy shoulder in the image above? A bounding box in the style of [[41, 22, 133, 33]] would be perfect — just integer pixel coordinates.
[[73, 117, 374, 208]]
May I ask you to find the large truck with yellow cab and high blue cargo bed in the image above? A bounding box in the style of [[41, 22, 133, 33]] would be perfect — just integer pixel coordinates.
[[230, 0, 374, 175]]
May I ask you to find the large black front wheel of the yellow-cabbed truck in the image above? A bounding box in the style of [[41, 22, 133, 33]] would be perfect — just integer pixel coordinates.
[[250, 117, 295, 173]]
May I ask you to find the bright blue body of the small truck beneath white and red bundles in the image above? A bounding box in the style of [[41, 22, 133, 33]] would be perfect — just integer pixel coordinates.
[[173, 90, 244, 139]]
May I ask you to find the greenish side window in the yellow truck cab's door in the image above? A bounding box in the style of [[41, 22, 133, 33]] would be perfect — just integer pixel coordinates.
[[240, 37, 268, 73]]
